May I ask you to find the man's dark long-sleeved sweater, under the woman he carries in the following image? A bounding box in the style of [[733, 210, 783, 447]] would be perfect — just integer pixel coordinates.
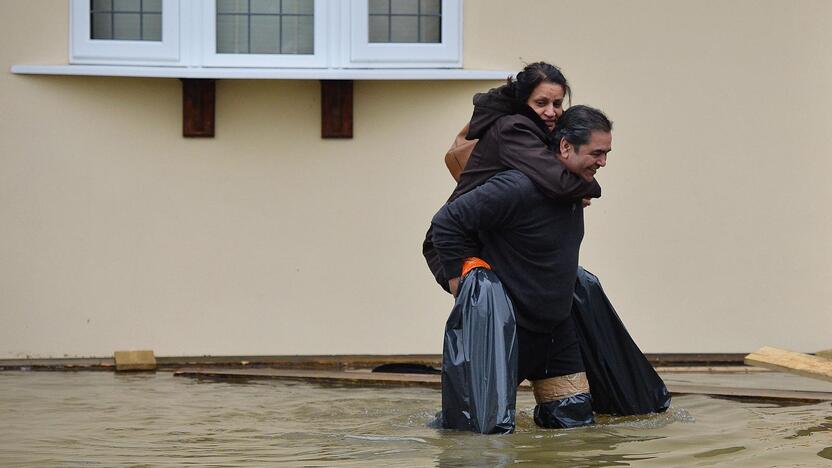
[[431, 170, 584, 333]]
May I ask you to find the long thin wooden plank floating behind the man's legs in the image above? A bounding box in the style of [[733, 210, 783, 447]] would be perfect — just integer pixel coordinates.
[[174, 369, 832, 402]]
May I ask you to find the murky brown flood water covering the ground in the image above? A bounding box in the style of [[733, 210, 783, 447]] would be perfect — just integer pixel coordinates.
[[0, 371, 832, 467]]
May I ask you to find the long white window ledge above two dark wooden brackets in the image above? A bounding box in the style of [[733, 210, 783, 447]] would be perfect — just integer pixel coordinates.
[[11, 65, 514, 81]]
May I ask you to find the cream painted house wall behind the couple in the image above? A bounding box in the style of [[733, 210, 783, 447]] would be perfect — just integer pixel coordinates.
[[0, 0, 832, 358]]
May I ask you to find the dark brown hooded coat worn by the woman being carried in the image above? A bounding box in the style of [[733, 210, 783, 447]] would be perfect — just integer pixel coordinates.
[[422, 86, 601, 291]]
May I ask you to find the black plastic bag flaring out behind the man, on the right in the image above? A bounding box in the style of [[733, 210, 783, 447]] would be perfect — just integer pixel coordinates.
[[572, 267, 670, 416]]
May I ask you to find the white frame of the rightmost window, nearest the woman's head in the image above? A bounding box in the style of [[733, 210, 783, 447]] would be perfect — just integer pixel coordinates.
[[348, 0, 462, 68]]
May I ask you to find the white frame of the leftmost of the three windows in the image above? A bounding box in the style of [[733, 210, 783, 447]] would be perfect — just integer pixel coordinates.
[[69, 0, 180, 65]]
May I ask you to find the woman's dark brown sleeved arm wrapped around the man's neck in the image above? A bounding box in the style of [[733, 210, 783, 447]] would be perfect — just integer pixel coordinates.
[[495, 119, 601, 200]]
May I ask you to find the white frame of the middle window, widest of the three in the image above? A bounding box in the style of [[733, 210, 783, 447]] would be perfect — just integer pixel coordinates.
[[202, 0, 330, 68]]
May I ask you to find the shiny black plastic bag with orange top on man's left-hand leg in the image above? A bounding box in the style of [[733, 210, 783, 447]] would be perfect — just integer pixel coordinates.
[[441, 268, 517, 434]]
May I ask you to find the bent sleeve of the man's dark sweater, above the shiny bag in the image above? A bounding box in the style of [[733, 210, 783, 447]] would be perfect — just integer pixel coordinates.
[[431, 170, 534, 279]]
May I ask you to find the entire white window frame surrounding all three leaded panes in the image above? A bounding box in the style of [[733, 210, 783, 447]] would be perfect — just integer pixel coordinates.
[[69, 0, 463, 70]]
